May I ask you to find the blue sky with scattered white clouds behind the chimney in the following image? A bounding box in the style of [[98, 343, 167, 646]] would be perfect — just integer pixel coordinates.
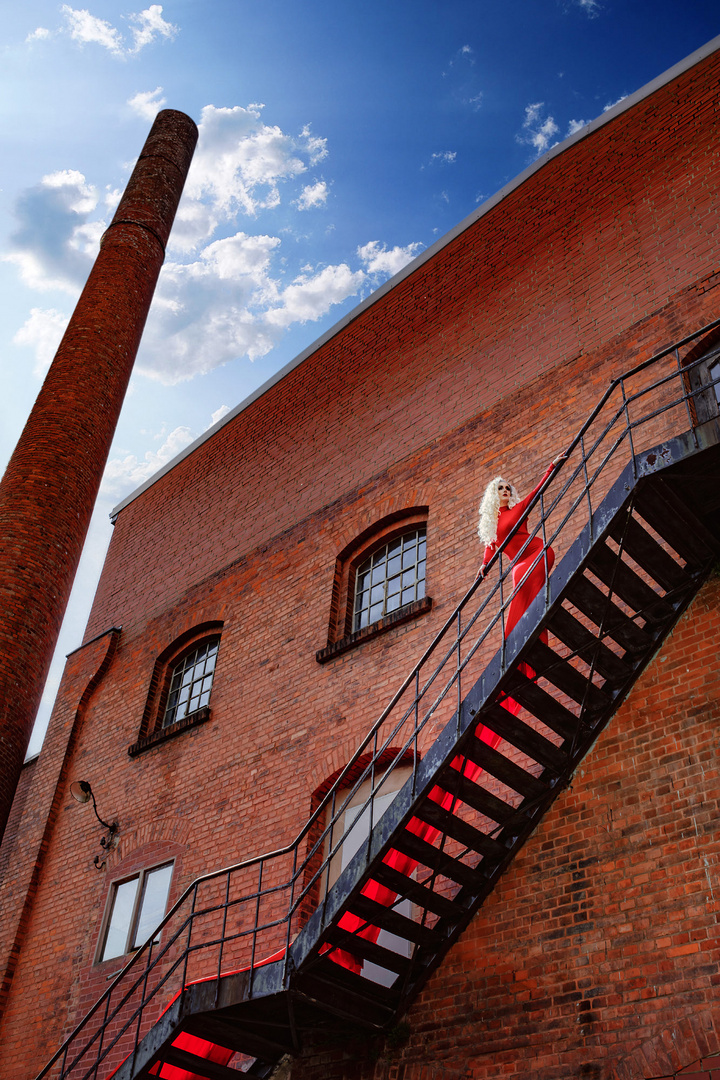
[[0, 0, 720, 750]]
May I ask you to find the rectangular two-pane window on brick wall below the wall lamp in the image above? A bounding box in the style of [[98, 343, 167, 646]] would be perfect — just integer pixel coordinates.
[[98, 862, 173, 962]]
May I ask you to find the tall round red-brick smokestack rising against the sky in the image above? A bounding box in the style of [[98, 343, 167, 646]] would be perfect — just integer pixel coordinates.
[[0, 109, 198, 837]]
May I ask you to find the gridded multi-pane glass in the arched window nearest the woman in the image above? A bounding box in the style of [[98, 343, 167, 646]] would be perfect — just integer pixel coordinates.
[[353, 526, 426, 631]]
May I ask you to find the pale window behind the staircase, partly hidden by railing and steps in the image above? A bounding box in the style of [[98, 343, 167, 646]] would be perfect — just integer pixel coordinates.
[[326, 767, 412, 986]]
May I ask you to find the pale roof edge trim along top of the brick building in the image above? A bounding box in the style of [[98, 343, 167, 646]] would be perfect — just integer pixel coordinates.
[[110, 35, 720, 522]]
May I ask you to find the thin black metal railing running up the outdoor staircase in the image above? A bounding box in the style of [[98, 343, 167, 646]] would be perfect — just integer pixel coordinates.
[[37, 319, 720, 1080]]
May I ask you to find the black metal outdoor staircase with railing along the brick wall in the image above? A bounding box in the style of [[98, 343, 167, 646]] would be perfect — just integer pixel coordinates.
[[38, 321, 720, 1080]]
